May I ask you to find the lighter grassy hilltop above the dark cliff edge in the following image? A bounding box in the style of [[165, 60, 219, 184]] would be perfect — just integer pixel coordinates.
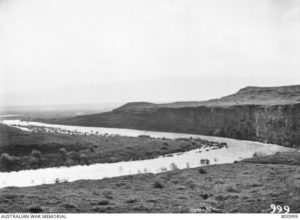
[[115, 85, 300, 111]]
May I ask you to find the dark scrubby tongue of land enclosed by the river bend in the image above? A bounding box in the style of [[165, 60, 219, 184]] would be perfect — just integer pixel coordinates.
[[0, 124, 223, 171]]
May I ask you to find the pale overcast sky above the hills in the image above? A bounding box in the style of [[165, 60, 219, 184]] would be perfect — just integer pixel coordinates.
[[0, 0, 300, 104]]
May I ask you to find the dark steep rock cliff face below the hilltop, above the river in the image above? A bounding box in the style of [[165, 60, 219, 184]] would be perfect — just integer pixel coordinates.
[[61, 103, 300, 148]]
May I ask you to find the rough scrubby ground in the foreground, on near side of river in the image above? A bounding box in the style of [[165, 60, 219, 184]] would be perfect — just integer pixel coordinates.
[[0, 153, 300, 213]]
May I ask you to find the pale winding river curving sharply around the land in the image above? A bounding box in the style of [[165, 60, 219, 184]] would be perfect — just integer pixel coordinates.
[[0, 120, 294, 188]]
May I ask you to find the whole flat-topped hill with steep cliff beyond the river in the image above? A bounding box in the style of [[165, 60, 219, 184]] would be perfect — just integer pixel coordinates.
[[47, 86, 300, 148]]
